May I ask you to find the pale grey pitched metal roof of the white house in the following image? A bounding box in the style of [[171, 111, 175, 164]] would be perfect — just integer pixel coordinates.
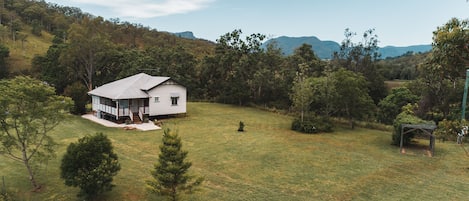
[[88, 73, 170, 100]]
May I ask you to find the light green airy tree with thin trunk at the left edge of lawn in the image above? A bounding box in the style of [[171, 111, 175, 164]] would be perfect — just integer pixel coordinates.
[[0, 76, 72, 189]]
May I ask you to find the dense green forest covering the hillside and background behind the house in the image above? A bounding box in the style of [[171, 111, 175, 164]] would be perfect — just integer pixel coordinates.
[[0, 0, 469, 131]]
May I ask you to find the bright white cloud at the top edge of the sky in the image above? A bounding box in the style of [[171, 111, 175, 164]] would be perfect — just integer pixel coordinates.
[[65, 0, 214, 18]]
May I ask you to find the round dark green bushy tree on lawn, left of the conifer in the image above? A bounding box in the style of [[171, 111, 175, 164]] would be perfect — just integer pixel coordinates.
[[60, 133, 121, 198]]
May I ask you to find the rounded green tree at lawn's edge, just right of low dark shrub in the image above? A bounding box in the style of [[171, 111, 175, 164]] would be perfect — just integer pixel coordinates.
[[331, 68, 376, 128]]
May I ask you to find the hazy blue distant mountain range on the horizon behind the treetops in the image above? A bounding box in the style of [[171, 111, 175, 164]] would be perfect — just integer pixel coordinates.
[[172, 31, 432, 59]]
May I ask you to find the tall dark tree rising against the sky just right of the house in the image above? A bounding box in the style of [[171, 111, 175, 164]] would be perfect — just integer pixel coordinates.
[[201, 30, 265, 105]]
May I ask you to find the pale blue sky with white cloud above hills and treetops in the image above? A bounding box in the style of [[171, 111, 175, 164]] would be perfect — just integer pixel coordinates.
[[46, 0, 469, 47]]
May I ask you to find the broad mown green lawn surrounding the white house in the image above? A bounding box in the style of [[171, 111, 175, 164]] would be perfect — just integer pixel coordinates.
[[0, 103, 469, 200]]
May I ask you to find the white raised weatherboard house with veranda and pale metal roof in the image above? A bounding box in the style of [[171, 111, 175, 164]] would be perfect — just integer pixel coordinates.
[[88, 73, 187, 122]]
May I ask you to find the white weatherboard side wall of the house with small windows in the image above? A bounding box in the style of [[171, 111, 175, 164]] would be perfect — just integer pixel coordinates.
[[148, 82, 187, 116]]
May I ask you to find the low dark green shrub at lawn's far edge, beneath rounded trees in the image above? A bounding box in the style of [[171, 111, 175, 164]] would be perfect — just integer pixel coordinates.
[[292, 115, 332, 133]]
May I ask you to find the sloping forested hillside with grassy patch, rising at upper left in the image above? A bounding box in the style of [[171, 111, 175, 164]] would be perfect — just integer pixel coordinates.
[[0, 0, 214, 75]]
